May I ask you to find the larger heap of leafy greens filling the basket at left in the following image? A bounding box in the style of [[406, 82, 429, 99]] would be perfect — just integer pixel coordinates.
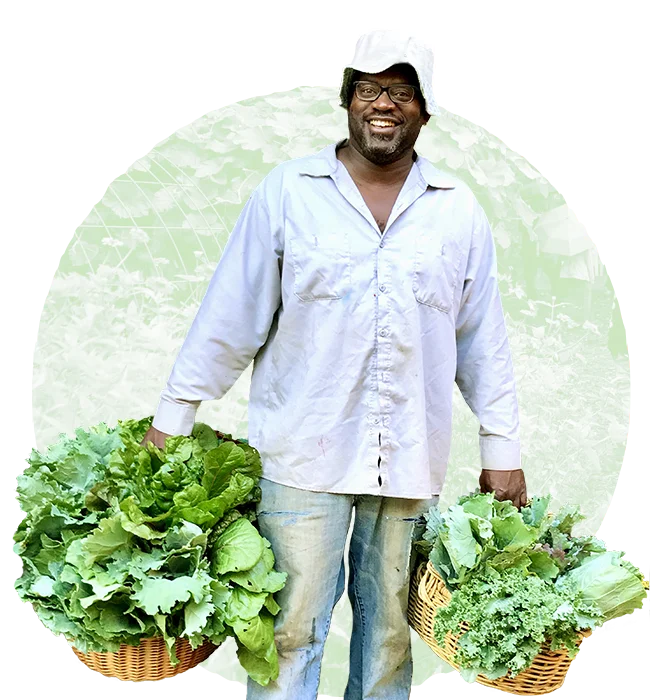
[[12, 417, 286, 685]]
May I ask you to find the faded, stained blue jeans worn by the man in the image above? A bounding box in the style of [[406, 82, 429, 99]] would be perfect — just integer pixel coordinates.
[[247, 479, 437, 700]]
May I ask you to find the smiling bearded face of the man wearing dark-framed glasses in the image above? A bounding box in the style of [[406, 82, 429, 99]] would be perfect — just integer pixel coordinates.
[[348, 64, 429, 165]]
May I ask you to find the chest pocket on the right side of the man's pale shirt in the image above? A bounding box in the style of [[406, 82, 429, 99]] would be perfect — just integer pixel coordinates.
[[413, 232, 461, 313]]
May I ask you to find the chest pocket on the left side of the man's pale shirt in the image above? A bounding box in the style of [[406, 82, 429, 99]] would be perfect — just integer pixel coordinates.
[[290, 231, 351, 301]]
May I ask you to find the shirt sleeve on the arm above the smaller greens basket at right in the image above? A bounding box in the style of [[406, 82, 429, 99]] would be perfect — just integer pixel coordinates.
[[456, 201, 521, 470]]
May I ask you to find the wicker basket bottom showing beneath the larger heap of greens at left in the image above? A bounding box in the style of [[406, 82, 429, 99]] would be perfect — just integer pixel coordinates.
[[71, 637, 218, 682]]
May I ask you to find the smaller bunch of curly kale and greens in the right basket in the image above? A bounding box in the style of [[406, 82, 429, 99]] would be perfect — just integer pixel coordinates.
[[415, 493, 647, 683]]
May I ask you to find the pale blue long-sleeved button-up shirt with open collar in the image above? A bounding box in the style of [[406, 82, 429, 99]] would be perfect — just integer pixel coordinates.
[[154, 139, 520, 498]]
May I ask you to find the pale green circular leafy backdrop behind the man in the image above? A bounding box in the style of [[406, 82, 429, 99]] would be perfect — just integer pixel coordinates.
[[33, 86, 632, 697]]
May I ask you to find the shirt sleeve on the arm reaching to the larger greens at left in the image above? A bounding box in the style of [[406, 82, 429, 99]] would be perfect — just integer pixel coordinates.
[[153, 188, 281, 435]]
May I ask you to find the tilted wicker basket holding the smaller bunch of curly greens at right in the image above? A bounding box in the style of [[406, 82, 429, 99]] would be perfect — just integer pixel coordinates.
[[408, 561, 590, 695]]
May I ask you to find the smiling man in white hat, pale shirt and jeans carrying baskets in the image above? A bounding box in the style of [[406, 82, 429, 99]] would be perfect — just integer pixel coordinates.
[[145, 32, 526, 700]]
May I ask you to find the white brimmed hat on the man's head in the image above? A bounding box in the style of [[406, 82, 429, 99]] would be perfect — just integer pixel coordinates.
[[339, 30, 442, 116]]
